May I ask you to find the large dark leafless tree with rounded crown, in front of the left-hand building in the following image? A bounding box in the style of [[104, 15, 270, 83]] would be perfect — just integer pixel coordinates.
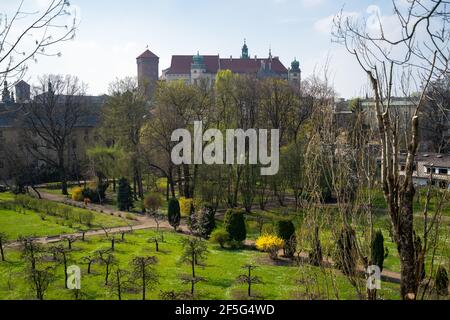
[[22, 75, 87, 195]]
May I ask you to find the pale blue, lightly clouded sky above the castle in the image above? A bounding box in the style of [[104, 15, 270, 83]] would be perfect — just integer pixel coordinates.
[[0, 0, 406, 98]]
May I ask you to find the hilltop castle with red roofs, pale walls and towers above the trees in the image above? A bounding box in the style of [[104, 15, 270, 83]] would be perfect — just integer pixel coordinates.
[[137, 40, 301, 94]]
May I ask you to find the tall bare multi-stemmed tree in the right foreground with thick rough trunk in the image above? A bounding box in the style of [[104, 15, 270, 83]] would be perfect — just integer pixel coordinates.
[[333, 0, 450, 299]]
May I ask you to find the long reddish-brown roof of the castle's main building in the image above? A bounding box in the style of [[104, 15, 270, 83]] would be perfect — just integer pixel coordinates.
[[167, 55, 288, 74]]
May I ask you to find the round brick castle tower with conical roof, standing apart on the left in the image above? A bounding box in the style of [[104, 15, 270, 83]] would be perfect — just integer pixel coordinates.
[[136, 49, 159, 98]]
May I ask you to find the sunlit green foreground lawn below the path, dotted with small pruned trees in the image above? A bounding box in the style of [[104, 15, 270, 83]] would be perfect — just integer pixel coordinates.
[[0, 230, 398, 300]]
